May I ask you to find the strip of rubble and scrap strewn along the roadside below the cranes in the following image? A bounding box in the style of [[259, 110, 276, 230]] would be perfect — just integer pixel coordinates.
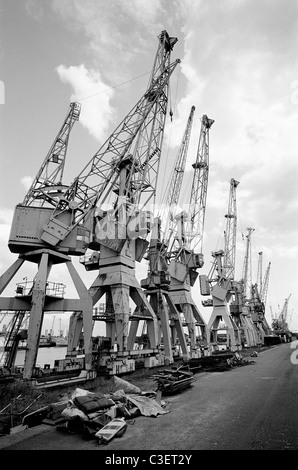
[[1, 351, 258, 444]]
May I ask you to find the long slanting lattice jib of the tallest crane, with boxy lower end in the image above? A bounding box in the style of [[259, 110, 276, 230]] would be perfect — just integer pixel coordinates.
[[41, 59, 181, 246]]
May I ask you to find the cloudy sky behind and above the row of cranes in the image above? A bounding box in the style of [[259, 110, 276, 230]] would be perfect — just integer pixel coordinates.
[[0, 0, 298, 338]]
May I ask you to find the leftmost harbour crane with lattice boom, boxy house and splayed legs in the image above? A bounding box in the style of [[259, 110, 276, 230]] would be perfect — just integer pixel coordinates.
[[0, 102, 84, 379]]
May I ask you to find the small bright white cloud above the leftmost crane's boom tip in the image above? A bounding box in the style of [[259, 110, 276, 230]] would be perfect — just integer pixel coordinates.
[[56, 64, 115, 141]]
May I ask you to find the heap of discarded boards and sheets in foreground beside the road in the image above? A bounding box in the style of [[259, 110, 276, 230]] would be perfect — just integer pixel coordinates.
[[57, 376, 169, 444]]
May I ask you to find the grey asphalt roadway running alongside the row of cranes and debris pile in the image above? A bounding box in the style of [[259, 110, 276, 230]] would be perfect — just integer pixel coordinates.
[[0, 343, 298, 454]]
